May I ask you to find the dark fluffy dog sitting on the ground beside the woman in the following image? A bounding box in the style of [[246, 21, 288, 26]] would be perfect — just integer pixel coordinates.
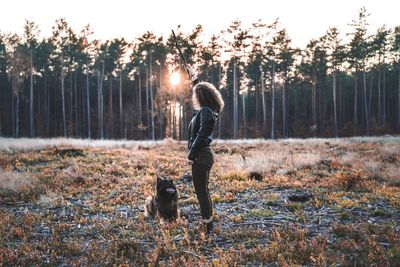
[[144, 177, 179, 221]]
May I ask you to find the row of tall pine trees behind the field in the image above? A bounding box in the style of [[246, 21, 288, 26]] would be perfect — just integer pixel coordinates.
[[0, 8, 400, 140]]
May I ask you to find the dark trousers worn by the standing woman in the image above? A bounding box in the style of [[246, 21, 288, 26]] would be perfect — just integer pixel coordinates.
[[192, 147, 214, 220]]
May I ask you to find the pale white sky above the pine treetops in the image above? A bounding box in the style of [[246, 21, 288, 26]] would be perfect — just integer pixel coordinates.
[[0, 0, 400, 48]]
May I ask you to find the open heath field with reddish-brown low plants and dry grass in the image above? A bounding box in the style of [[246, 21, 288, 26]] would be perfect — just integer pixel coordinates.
[[0, 137, 400, 266]]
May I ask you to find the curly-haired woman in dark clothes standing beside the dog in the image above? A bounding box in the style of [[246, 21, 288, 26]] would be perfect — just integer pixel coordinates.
[[188, 82, 224, 234]]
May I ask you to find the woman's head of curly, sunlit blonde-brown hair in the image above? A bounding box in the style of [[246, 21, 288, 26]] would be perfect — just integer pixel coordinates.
[[192, 82, 224, 112]]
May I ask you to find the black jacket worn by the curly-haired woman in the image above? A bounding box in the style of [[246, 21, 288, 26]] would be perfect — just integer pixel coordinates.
[[188, 106, 218, 160]]
